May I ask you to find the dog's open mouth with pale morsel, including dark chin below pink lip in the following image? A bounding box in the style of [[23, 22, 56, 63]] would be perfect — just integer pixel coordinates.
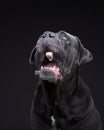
[[35, 51, 63, 82]]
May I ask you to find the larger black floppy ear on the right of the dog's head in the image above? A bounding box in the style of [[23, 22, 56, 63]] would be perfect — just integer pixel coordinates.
[[78, 38, 93, 65]]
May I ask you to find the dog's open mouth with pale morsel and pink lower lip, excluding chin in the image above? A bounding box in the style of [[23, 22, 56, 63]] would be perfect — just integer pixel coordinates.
[[35, 51, 62, 80]]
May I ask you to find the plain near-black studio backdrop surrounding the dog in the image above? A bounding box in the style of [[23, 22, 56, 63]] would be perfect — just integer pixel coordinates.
[[0, 0, 104, 130]]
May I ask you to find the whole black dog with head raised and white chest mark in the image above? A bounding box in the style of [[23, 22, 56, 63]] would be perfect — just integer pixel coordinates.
[[29, 31, 102, 130]]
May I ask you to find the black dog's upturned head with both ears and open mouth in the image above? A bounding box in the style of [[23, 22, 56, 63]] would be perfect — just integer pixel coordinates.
[[29, 31, 93, 84]]
